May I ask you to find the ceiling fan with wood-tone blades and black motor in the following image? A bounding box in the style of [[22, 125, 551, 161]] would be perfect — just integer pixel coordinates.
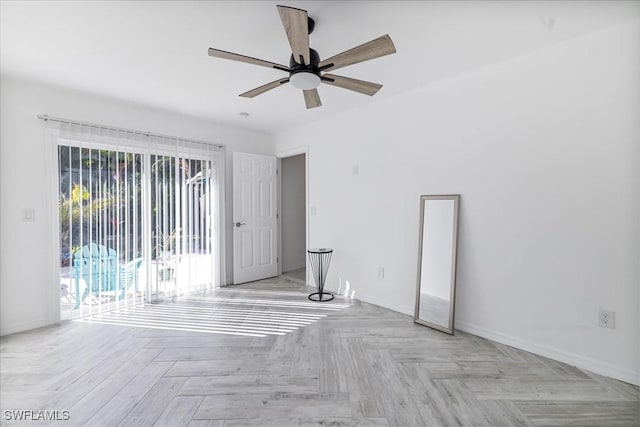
[[209, 6, 396, 108]]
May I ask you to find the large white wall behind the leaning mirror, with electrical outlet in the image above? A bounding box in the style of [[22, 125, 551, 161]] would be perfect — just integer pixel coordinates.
[[276, 20, 640, 383]]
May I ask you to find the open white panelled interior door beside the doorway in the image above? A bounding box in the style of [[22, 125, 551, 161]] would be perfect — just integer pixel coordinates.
[[233, 153, 278, 284]]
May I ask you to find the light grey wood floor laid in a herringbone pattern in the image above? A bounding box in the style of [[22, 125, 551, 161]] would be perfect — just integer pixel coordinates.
[[0, 278, 640, 427]]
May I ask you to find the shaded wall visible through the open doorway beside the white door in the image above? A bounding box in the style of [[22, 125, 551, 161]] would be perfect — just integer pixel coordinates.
[[280, 154, 307, 272]]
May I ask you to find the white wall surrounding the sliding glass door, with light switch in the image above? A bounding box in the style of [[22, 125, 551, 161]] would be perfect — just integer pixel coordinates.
[[0, 78, 273, 335]]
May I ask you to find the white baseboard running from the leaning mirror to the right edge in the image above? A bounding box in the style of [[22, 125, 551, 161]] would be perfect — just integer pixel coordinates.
[[455, 320, 640, 385]]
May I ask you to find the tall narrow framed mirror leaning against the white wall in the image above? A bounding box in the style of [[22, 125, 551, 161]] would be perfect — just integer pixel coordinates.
[[414, 194, 460, 334]]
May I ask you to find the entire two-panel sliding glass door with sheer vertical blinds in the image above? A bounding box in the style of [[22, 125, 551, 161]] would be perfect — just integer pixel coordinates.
[[57, 132, 220, 319]]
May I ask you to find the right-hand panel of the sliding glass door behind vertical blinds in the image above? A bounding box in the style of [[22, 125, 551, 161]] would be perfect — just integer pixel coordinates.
[[149, 155, 215, 301]]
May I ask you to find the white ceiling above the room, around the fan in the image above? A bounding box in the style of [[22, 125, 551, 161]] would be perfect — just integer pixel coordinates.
[[0, 0, 640, 132]]
